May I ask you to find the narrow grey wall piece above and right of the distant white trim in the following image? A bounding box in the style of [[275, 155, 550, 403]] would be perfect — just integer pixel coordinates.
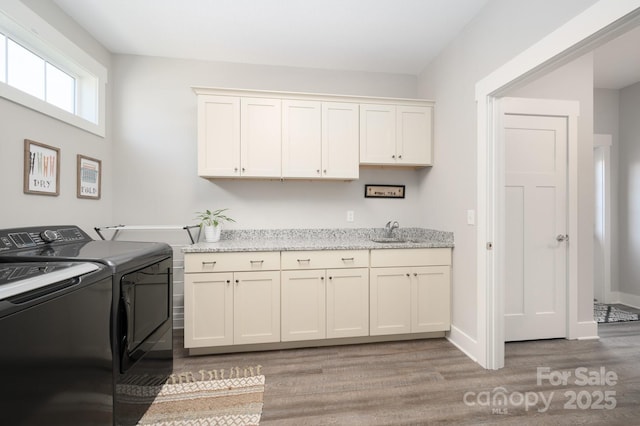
[[593, 89, 620, 292]]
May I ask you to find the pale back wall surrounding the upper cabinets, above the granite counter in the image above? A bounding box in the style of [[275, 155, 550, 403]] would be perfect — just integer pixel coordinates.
[[112, 56, 428, 229]]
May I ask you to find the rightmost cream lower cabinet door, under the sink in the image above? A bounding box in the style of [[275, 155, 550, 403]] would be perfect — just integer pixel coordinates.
[[411, 266, 451, 333]]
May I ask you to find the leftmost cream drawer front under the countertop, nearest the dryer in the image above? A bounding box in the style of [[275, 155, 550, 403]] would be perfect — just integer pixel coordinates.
[[184, 251, 280, 273]]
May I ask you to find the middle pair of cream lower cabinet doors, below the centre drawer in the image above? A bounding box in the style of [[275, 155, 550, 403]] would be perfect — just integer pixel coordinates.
[[281, 268, 369, 342]]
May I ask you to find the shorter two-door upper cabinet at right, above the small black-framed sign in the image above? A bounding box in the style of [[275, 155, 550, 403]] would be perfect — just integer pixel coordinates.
[[360, 104, 433, 166]]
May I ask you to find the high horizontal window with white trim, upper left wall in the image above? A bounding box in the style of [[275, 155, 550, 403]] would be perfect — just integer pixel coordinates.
[[0, 0, 107, 136]]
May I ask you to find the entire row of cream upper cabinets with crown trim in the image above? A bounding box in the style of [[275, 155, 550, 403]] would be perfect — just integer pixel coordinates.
[[194, 88, 433, 180]]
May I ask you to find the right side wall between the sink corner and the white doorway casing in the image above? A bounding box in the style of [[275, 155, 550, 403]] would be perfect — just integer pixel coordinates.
[[419, 0, 595, 357]]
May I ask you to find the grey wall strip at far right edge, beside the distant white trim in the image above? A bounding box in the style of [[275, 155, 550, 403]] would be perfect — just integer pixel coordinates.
[[618, 83, 640, 298]]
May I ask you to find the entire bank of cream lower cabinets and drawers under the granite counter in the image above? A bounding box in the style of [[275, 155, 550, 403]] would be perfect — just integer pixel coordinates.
[[184, 248, 451, 349]]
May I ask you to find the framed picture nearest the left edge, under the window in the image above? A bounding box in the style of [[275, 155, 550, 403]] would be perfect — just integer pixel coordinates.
[[23, 139, 60, 196]]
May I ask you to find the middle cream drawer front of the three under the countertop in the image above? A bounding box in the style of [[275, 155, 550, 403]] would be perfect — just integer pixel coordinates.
[[282, 250, 369, 269]]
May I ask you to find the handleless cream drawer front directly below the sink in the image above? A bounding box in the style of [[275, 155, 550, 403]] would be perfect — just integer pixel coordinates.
[[371, 248, 451, 268]]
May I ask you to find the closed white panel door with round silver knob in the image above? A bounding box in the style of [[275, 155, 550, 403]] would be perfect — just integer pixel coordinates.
[[504, 114, 567, 341]]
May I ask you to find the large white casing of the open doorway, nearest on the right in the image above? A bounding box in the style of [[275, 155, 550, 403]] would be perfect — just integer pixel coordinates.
[[476, 0, 640, 369]]
